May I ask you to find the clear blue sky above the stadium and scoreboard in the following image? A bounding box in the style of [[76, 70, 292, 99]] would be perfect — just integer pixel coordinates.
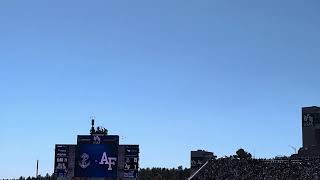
[[0, 0, 320, 178]]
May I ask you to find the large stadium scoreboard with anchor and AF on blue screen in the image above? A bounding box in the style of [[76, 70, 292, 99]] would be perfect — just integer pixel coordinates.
[[54, 131, 139, 180]]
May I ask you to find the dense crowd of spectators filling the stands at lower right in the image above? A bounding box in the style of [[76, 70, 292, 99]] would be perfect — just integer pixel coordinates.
[[193, 157, 320, 180]]
